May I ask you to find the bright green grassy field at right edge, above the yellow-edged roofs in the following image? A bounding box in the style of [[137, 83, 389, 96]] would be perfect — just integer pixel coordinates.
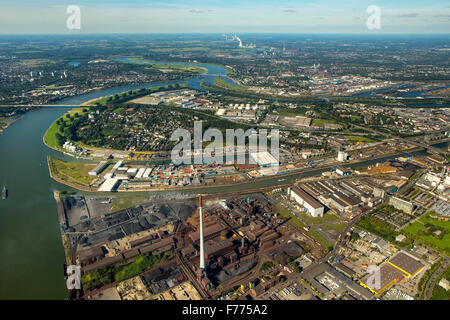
[[403, 213, 450, 255]]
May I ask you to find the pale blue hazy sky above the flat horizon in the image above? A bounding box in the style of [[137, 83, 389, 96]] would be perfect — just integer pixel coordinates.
[[0, 0, 450, 34]]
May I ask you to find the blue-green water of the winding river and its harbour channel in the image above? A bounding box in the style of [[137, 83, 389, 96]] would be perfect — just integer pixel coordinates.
[[0, 60, 446, 299]]
